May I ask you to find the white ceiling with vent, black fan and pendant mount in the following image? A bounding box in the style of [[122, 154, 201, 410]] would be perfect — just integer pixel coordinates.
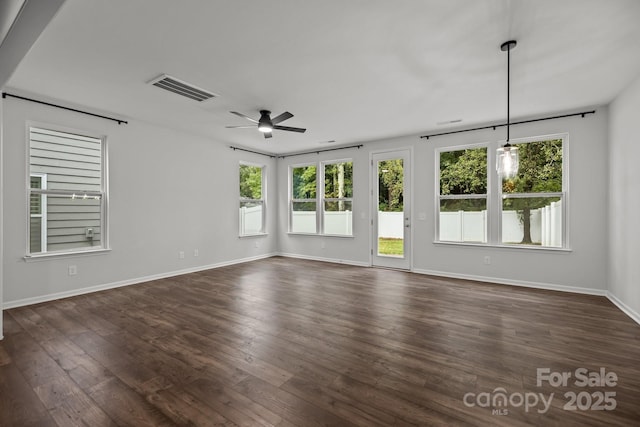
[[7, 0, 640, 153]]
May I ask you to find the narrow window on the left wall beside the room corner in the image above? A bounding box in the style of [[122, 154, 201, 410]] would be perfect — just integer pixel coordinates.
[[240, 163, 266, 236]]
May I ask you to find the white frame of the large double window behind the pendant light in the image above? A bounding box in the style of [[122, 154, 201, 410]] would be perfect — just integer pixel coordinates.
[[434, 132, 571, 251]]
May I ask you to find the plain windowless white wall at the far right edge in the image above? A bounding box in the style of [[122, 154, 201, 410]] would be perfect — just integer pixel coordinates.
[[608, 76, 640, 322]]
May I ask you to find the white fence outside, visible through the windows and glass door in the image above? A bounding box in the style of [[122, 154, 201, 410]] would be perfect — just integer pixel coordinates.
[[240, 202, 562, 247]]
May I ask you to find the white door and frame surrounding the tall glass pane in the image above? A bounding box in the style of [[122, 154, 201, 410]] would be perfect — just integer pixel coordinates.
[[369, 147, 413, 270]]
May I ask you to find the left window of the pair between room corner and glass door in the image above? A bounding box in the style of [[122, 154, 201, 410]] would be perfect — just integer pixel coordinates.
[[289, 165, 318, 233]]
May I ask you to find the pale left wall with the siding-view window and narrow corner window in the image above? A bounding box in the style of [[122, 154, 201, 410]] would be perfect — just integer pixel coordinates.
[[2, 98, 277, 306]]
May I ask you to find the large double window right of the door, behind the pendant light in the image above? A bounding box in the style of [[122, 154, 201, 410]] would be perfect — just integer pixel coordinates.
[[436, 136, 567, 248]]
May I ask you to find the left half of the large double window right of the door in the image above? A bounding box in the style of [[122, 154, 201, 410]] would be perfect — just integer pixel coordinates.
[[438, 147, 488, 243]]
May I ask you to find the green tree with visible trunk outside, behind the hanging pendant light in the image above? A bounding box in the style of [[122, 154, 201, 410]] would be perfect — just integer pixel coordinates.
[[502, 139, 562, 244]]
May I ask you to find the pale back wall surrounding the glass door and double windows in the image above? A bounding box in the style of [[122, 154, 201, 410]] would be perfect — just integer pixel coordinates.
[[278, 108, 609, 294]]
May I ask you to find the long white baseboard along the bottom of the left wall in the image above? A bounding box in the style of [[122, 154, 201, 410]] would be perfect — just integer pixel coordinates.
[[3, 253, 278, 310]]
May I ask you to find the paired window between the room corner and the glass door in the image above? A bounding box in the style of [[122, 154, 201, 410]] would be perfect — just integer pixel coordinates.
[[289, 160, 353, 236]]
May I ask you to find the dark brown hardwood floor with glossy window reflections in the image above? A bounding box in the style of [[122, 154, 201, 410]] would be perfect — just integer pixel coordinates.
[[0, 257, 640, 427]]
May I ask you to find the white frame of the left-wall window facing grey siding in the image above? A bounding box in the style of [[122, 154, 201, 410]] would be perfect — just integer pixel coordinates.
[[24, 121, 110, 261]]
